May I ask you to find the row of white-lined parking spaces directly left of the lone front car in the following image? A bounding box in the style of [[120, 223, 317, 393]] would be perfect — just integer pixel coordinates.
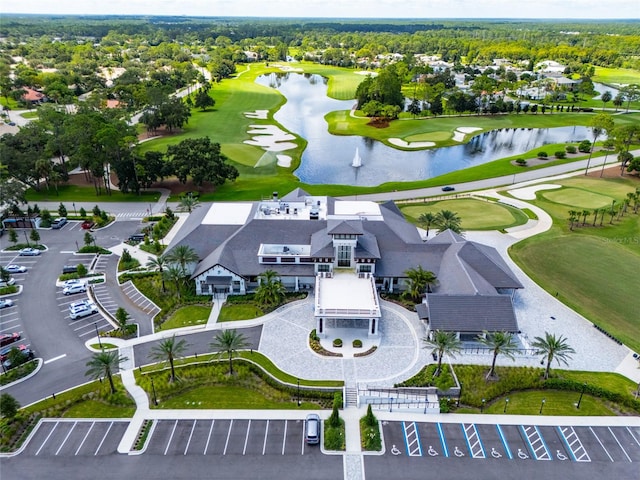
[[145, 419, 322, 456]]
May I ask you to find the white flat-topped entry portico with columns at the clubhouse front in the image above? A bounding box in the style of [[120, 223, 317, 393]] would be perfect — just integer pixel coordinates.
[[315, 271, 381, 338]]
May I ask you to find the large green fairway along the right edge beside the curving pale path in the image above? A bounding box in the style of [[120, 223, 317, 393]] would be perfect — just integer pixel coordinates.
[[510, 178, 640, 350]]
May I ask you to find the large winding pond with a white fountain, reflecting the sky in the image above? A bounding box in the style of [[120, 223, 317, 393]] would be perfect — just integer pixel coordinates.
[[256, 73, 592, 186]]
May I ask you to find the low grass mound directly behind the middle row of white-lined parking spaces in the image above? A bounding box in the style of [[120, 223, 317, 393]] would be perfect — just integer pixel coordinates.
[[158, 385, 318, 410]]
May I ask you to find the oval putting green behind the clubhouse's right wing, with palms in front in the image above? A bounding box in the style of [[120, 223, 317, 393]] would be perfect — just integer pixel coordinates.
[[399, 199, 528, 230]]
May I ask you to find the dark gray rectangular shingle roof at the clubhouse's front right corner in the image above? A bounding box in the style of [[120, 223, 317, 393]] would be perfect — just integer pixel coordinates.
[[427, 294, 518, 333]]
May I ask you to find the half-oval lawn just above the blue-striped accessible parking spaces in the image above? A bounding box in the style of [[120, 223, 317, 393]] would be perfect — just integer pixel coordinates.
[[484, 390, 615, 417]]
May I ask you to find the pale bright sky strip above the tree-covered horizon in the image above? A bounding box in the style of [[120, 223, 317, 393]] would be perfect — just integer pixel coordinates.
[[0, 0, 640, 21]]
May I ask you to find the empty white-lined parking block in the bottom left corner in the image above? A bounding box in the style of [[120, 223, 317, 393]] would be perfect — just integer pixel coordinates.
[[22, 419, 129, 457]]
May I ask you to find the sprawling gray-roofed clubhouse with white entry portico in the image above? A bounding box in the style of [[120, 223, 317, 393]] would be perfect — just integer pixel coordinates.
[[168, 189, 523, 340]]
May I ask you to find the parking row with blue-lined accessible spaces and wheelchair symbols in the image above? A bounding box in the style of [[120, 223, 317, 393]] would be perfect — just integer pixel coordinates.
[[383, 422, 640, 463]]
